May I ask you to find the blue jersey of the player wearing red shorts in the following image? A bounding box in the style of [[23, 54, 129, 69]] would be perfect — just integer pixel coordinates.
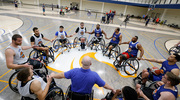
[[126, 41, 139, 57]]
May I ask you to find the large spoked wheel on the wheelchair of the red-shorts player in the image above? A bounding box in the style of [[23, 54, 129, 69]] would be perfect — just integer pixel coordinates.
[[123, 58, 139, 75]]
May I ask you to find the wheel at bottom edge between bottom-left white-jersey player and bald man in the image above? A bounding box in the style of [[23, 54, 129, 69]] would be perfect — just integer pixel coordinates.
[[45, 87, 64, 100]]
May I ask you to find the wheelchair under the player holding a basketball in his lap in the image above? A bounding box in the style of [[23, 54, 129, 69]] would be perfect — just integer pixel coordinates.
[[133, 68, 159, 89]]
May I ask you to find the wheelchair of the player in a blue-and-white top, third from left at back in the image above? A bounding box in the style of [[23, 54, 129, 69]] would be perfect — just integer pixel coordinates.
[[53, 39, 71, 54]]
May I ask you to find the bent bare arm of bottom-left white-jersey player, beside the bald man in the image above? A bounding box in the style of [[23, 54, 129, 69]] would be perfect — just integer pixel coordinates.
[[30, 77, 52, 100]]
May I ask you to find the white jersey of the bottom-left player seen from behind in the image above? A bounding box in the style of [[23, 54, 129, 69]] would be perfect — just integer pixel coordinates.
[[18, 75, 47, 99]]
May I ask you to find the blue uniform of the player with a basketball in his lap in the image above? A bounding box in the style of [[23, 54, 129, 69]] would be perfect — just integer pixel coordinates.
[[153, 60, 179, 81]]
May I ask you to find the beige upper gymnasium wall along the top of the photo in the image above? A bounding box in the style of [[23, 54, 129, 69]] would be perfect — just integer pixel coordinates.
[[21, 0, 180, 25]]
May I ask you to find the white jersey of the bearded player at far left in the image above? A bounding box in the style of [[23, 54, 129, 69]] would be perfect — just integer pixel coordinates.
[[6, 45, 28, 64]]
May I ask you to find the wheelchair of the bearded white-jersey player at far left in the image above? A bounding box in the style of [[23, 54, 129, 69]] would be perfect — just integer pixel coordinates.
[[9, 59, 48, 93]]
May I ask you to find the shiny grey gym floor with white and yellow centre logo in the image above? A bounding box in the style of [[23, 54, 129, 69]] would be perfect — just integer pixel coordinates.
[[0, 3, 180, 100]]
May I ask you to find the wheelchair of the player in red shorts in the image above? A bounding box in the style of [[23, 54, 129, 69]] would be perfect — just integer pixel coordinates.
[[113, 54, 139, 75]]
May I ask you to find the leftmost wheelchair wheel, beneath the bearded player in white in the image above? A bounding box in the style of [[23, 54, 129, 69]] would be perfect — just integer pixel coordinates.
[[9, 71, 19, 93]]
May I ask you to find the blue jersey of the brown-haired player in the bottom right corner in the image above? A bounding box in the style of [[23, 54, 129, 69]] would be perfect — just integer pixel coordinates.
[[153, 85, 178, 100]]
